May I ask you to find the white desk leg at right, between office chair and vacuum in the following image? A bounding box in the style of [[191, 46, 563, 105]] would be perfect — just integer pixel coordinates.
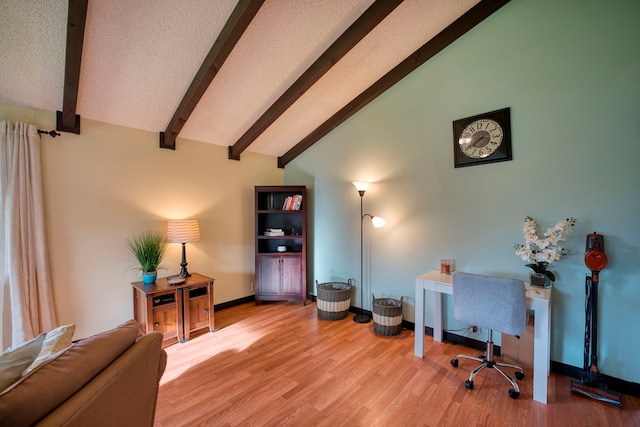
[[533, 305, 551, 404]]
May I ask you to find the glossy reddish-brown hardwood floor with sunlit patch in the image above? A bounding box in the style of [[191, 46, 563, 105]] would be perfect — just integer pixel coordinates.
[[156, 303, 640, 427]]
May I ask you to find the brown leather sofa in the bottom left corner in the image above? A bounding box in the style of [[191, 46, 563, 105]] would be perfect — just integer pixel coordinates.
[[0, 320, 167, 427]]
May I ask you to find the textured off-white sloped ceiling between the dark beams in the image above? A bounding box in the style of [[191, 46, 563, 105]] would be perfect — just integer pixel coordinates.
[[0, 0, 478, 157]]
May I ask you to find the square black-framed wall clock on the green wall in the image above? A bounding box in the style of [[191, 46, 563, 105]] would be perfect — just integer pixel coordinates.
[[453, 108, 511, 168]]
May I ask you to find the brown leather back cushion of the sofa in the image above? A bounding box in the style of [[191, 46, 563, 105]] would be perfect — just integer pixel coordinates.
[[0, 320, 139, 426]]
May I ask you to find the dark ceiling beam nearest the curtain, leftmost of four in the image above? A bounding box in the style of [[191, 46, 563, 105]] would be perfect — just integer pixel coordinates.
[[56, 0, 88, 134]]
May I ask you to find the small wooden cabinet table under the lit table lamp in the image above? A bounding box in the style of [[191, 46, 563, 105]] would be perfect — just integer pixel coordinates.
[[131, 273, 215, 347]]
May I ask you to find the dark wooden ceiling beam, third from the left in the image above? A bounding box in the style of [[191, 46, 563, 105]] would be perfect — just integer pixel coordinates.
[[229, 0, 402, 160]]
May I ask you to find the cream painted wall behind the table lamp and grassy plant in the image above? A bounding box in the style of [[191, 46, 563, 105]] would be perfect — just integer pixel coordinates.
[[0, 103, 282, 338]]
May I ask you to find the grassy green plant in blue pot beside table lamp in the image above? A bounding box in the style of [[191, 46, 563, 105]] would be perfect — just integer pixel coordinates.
[[127, 230, 167, 284]]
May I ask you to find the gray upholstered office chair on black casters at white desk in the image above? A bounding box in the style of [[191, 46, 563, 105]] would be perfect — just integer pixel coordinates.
[[451, 272, 527, 399]]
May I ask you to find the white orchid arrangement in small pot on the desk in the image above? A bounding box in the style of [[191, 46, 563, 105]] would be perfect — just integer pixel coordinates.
[[514, 217, 576, 281]]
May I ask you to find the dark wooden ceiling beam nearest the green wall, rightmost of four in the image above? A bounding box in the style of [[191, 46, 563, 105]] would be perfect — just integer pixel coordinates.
[[278, 0, 510, 168]]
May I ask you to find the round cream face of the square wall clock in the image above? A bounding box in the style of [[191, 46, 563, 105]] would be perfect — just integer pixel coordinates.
[[458, 119, 504, 159]]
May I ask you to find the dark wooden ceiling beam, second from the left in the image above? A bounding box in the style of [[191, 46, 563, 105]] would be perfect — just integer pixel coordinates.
[[160, 0, 264, 150]]
